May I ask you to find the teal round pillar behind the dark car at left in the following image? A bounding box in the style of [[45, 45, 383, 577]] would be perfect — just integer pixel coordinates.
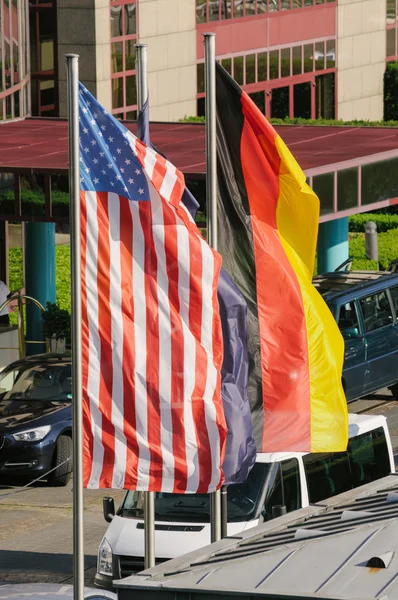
[[25, 223, 55, 355]]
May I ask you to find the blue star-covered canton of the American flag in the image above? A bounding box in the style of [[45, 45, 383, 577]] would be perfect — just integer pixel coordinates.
[[79, 83, 149, 200]]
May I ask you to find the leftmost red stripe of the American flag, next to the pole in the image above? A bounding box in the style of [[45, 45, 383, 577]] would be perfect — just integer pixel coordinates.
[[80, 192, 94, 487]]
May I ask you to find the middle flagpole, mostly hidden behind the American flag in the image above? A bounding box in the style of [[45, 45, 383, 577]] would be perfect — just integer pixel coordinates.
[[135, 44, 155, 569]]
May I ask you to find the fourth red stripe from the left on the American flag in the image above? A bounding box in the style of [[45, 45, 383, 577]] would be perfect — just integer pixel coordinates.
[[139, 202, 163, 491]]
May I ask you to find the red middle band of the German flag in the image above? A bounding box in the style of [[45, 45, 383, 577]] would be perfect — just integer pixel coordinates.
[[241, 93, 311, 452]]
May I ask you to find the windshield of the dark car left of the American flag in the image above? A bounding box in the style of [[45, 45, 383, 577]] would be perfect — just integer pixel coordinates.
[[0, 361, 72, 401]]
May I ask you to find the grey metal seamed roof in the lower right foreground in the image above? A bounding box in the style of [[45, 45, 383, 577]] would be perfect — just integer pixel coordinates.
[[114, 475, 398, 600]]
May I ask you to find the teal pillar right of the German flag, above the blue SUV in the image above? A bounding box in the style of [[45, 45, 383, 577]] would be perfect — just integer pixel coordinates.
[[318, 217, 349, 273]]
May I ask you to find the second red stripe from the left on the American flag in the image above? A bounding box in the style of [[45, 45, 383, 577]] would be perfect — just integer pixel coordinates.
[[97, 192, 115, 487]]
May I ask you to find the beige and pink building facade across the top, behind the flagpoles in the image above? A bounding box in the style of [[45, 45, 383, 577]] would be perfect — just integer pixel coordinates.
[[0, 0, 388, 121]]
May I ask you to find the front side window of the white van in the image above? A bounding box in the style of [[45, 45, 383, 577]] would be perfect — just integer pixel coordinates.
[[264, 458, 301, 521]]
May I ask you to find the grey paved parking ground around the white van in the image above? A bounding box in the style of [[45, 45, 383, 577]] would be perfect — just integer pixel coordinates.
[[0, 390, 398, 585]]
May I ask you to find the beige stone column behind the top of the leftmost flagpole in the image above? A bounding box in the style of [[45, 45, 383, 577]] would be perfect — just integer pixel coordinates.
[[57, 0, 112, 117]]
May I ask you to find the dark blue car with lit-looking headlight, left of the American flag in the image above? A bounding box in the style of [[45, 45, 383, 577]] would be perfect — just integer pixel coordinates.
[[0, 354, 72, 486]]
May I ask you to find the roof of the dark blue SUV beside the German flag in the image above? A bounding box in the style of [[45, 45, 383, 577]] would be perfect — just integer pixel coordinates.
[[313, 271, 398, 303]]
